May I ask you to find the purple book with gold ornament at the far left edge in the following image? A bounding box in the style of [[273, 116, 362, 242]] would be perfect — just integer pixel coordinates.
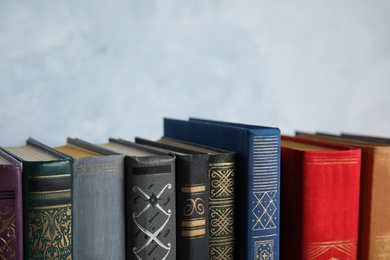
[[0, 150, 23, 260]]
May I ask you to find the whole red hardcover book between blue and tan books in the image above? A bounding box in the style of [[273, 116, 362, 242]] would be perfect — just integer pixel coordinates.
[[280, 136, 361, 260]]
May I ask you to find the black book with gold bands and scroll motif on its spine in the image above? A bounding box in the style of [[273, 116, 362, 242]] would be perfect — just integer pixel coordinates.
[[135, 138, 209, 260]]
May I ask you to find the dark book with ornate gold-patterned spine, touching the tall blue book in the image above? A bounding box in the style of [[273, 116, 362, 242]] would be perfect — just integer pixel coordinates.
[[158, 137, 236, 260]]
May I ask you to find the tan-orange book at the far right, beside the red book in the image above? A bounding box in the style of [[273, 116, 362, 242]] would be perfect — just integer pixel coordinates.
[[297, 132, 390, 259]]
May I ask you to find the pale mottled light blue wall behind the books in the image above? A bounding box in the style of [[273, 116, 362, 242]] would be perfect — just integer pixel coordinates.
[[0, 0, 390, 146]]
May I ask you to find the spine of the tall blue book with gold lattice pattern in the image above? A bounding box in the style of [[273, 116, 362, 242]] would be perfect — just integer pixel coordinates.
[[250, 134, 280, 260]]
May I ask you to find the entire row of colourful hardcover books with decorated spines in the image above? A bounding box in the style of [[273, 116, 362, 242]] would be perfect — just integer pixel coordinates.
[[0, 118, 390, 260]]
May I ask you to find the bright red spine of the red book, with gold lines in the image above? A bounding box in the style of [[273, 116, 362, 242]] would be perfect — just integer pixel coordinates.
[[301, 151, 361, 260]]
